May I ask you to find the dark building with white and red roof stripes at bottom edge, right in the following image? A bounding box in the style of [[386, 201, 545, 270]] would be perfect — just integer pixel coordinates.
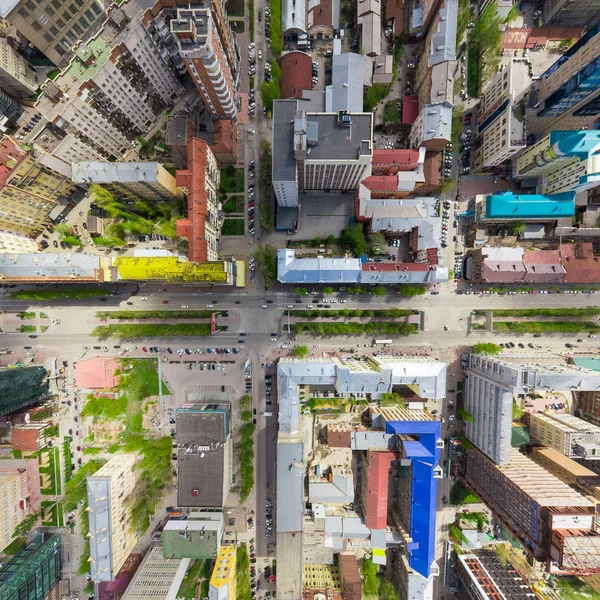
[[456, 548, 537, 600]]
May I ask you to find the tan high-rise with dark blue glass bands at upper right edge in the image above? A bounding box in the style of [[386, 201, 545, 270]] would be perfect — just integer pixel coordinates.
[[527, 22, 600, 136]]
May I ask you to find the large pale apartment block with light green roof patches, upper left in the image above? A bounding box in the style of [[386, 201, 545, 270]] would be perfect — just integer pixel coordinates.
[[37, 20, 183, 160]]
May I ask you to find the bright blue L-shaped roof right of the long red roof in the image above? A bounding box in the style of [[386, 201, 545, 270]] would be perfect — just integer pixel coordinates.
[[386, 421, 440, 578]]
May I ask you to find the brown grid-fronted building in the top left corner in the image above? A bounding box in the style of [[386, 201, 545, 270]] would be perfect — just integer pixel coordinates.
[[0, 0, 107, 66]]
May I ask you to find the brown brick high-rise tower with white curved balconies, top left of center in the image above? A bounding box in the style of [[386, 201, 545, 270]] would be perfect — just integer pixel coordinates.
[[171, 0, 240, 120]]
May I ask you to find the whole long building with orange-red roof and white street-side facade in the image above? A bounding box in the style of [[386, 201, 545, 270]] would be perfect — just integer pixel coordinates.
[[176, 138, 221, 262]]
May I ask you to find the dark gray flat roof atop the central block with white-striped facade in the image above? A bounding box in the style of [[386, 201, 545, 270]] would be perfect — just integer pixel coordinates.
[[308, 113, 373, 161]]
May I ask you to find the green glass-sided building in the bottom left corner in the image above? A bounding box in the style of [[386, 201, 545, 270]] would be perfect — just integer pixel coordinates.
[[0, 529, 63, 600]]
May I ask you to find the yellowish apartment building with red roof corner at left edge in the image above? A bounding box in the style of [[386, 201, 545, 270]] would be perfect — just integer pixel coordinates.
[[0, 136, 76, 237]]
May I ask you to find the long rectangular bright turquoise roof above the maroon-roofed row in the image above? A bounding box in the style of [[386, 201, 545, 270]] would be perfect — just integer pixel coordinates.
[[485, 192, 575, 219]]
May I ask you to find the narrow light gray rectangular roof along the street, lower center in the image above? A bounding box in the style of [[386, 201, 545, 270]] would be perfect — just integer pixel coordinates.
[[277, 442, 305, 534]]
